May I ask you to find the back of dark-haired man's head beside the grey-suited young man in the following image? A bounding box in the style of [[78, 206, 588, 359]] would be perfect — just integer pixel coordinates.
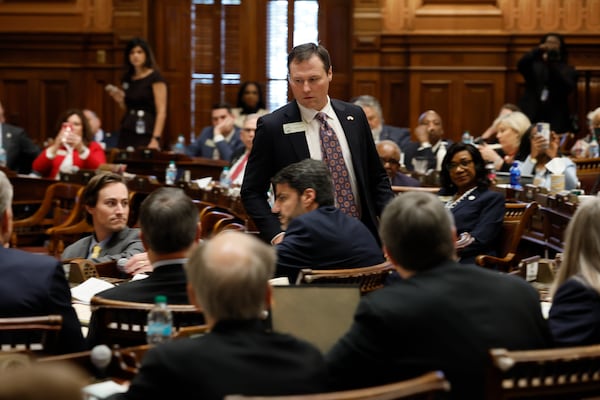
[[139, 187, 198, 254]]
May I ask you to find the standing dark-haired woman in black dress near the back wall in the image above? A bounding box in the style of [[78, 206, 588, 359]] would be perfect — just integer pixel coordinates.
[[106, 38, 167, 150]]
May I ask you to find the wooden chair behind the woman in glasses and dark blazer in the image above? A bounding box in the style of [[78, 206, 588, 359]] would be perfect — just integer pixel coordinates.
[[475, 201, 539, 272]]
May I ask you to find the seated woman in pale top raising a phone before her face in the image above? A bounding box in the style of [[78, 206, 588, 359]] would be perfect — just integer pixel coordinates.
[[521, 126, 579, 190]]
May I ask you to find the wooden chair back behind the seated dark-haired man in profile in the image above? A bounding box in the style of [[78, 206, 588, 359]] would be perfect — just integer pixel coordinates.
[[296, 262, 394, 294]]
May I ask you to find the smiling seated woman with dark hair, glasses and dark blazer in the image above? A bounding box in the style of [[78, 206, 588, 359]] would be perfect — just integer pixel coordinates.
[[440, 142, 504, 264]]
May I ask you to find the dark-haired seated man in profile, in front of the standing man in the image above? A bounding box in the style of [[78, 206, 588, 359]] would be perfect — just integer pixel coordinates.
[[273, 158, 384, 283]]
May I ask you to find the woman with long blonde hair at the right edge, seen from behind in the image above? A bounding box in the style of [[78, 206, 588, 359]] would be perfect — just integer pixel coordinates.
[[548, 198, 600, 346]]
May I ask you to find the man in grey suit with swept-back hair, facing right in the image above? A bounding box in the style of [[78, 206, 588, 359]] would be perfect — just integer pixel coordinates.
[[62, 173, 144, 264]]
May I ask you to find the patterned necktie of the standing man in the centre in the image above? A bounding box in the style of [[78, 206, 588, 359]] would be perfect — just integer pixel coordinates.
[[315, 112, 360, 218]]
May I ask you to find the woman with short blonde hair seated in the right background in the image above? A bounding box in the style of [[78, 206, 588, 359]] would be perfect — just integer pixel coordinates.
[[479, 111, 531, 172]]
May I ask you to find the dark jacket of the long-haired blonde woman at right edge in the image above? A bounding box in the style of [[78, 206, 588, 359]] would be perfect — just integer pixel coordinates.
[[548, 276, 600, 346]]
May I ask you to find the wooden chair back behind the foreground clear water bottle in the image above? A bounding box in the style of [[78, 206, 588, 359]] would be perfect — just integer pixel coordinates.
[[90, 296, 204, 347]]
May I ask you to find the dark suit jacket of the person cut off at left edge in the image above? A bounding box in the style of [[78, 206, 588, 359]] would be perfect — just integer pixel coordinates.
[[0, 246, 85, 353]]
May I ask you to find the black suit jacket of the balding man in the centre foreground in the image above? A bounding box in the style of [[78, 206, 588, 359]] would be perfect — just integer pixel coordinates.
[[106, 320, 326, 400]]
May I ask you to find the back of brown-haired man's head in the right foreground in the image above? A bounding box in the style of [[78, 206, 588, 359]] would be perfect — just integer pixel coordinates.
[[379, 192, 455, 271]]
